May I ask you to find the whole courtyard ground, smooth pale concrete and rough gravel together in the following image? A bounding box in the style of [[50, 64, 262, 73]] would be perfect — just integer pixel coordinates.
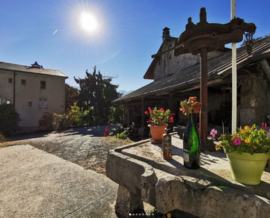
[[0, 125, 135, 218]]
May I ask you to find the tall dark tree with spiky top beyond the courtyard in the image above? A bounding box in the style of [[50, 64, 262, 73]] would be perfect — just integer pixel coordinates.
[[74, 67, 120, 124]]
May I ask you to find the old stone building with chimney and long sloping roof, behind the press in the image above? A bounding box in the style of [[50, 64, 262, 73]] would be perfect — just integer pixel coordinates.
[[114, 28, 270, 132]]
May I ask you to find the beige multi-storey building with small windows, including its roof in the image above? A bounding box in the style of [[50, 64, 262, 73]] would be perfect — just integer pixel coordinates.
[[0, 62, 68, 131]]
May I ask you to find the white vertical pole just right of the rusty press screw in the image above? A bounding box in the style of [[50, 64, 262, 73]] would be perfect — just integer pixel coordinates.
[[231, 0, 237, 134]]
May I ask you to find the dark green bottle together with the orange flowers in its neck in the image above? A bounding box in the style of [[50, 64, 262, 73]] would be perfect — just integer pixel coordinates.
[[180, 97, 202, 169]]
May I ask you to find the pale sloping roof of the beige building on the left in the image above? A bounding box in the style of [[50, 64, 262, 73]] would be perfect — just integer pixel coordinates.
[[0, 62, 68, 78]]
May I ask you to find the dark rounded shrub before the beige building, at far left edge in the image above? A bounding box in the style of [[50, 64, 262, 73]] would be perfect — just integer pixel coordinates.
[[0, 104, 21, 135]]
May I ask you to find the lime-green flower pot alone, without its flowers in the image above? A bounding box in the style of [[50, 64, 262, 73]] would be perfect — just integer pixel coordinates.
[[226, 151, 270, 185]]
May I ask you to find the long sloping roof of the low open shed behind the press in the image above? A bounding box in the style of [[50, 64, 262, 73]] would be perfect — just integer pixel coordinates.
[[114, 36, 270, 103]]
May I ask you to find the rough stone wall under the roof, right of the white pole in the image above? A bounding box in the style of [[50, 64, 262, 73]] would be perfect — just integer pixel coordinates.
[[240, 75, 270, 126]]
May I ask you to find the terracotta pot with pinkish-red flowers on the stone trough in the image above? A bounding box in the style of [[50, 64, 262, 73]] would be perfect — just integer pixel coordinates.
[[145, 107, 173, 143]]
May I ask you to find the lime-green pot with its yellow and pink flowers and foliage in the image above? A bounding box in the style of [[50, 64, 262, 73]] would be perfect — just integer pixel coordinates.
[[216, 124, 270, 185]]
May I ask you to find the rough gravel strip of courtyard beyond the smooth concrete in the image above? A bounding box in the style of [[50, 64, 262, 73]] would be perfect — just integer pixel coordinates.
[[7, 125, 132, 174]]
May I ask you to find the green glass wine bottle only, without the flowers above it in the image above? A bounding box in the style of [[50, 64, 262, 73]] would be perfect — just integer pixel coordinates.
[[183, 113, 200, 169]]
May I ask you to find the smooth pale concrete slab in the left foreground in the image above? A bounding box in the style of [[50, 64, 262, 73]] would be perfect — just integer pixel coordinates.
[[0, 145, 117, 218]]
